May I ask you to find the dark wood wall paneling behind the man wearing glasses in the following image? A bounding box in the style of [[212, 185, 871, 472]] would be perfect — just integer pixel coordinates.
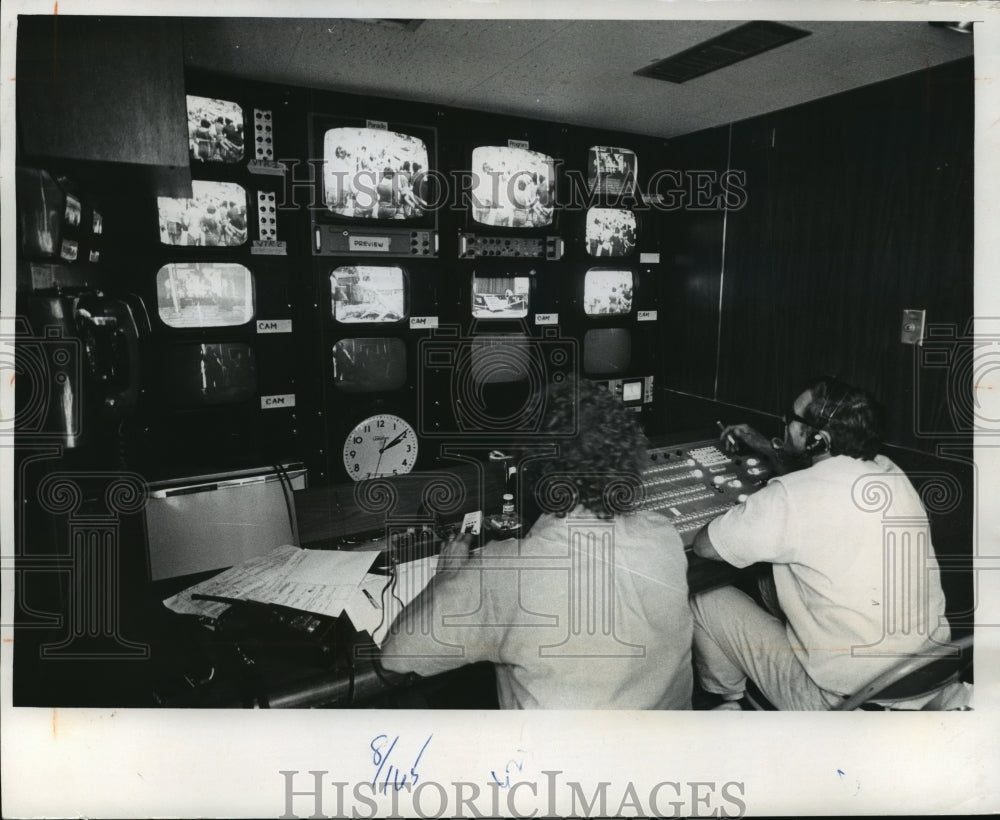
[[717, 61, 973, 450]]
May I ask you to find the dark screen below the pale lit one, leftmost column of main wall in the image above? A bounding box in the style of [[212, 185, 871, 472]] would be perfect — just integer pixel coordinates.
[[163, 342, 257, 408]]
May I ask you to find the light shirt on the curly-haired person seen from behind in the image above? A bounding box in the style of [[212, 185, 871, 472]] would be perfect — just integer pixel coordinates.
[[382, 508, 692, 709]]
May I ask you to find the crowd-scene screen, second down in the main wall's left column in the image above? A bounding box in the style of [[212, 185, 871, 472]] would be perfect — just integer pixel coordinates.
[[156, 179, 247, 248]]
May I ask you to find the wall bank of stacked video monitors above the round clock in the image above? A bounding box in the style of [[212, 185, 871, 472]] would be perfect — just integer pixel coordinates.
[[137, 82, 658, 480]]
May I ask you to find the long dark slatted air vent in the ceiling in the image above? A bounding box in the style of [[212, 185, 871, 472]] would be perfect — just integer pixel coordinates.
[[635, 20, 810, 83]]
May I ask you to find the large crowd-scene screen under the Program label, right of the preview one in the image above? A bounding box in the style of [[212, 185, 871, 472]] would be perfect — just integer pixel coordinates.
[[470, 145, 556, 228]]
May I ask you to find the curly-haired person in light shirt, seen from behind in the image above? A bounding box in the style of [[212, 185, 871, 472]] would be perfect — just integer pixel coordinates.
[[382, 382, 693, 709]]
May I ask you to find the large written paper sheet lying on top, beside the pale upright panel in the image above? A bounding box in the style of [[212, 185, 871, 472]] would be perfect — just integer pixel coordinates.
[[163, 544, 378, 618]]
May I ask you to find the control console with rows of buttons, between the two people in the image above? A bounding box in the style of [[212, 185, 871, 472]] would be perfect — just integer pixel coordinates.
[[642, 439, 772, 548]]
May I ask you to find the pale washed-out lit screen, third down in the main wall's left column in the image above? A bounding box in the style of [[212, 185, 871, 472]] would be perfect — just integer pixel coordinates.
[[156, 262, 254, 328]]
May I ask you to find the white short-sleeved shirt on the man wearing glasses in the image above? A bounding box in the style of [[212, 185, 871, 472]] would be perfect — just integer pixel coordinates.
[[708, 456, 950, 694]]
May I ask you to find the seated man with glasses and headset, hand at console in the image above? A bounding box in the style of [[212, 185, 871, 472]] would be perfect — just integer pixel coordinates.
[[691, 378, 950, 710]]
